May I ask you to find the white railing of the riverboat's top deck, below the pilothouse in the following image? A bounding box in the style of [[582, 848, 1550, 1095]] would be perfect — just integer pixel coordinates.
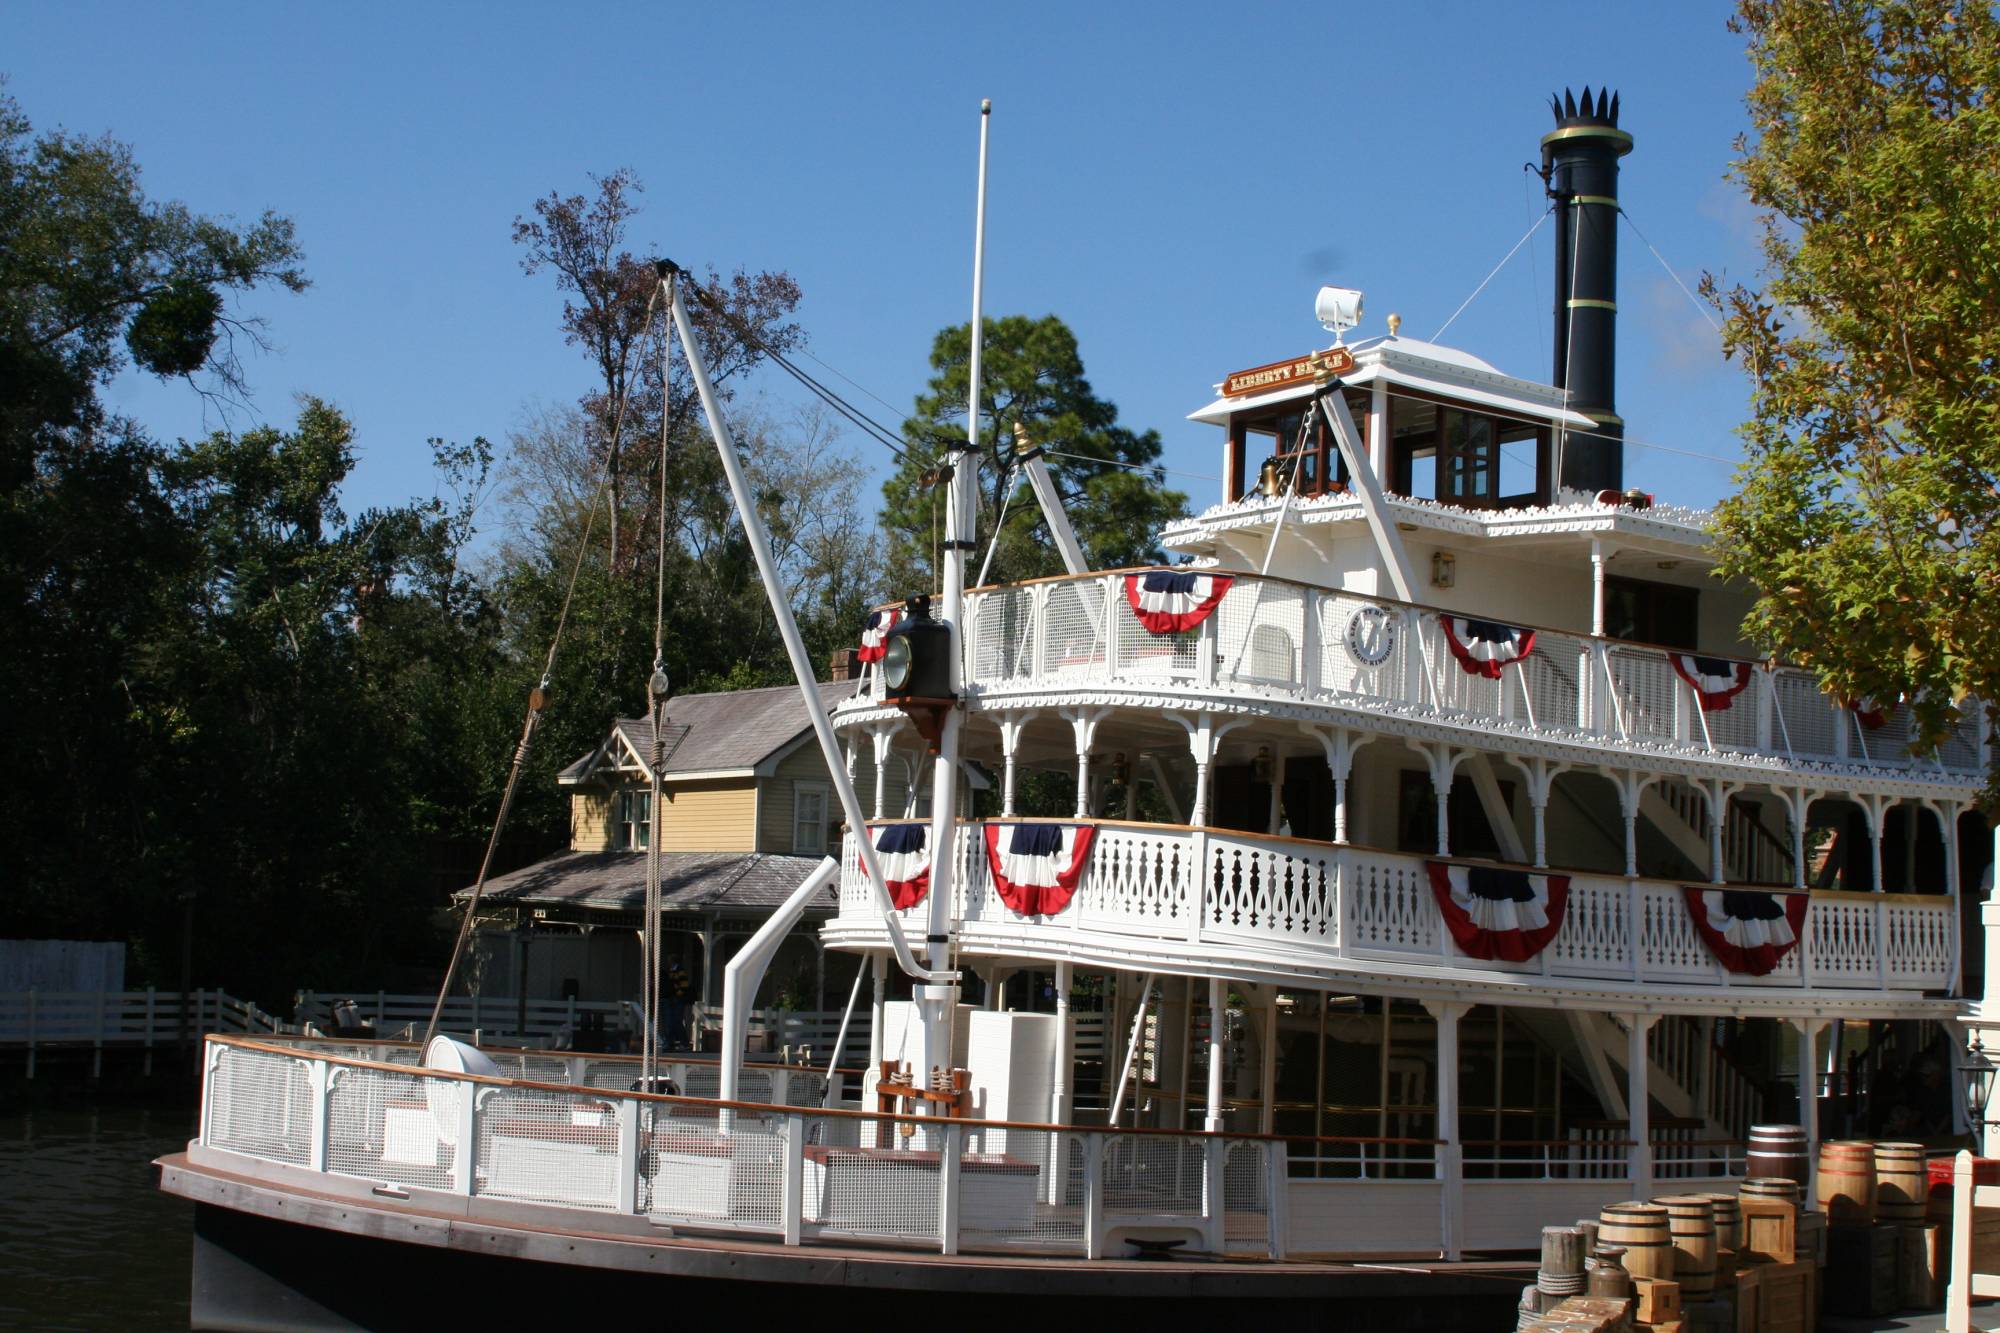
[[924, 572, 1986, 781]]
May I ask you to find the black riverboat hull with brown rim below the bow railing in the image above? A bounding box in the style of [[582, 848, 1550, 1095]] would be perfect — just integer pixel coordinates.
[[158, 1153, 1528, 1333]]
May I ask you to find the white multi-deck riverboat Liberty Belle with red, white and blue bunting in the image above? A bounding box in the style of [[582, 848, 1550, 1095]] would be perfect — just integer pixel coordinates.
[[164, 92, 1992, 1327]]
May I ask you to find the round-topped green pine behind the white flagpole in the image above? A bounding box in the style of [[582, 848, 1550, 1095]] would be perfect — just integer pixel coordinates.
[[882, 314, 1188, 590]]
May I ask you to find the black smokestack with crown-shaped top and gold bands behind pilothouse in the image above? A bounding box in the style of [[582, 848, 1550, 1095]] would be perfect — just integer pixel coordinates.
[[1542, 88, 1632, 490]]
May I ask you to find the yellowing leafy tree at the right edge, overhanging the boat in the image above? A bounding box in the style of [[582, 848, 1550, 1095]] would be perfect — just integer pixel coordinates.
[[1708, 0, 2000, 784]]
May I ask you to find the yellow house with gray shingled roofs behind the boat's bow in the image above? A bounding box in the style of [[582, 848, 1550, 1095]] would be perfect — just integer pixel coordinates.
[[456, 681, 916, 1009]]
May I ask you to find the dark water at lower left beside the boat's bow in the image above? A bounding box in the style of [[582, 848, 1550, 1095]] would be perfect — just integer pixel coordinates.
[[0, 1107, 194, 1331]]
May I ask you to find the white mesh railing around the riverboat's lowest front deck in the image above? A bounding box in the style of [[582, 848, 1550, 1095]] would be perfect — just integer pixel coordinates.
[[200, 1037, 1286, 1257]]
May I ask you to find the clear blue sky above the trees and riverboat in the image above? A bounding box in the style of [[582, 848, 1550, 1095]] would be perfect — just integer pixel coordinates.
[[0, 0, 1758, 528]]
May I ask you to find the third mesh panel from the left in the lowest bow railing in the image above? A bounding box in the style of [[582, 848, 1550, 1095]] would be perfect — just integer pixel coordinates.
[[472, 1085, 618, 1209]]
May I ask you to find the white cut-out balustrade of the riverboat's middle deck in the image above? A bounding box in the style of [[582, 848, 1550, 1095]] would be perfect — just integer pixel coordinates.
[[832, 821, 1952, 991]]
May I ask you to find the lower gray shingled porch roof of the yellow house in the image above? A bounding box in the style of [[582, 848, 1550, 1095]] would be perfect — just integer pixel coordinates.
[[454, 851, 838, 917]]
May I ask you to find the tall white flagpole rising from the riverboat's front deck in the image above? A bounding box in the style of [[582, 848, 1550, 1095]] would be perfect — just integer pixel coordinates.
[[918, 100, 994, 1104]]
